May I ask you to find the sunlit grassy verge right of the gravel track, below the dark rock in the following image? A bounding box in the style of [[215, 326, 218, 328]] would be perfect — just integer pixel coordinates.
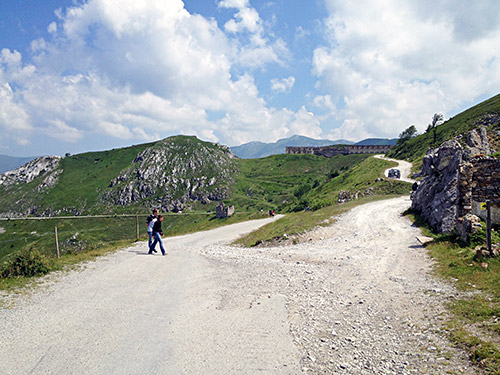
[[411, 215, 500, 374]]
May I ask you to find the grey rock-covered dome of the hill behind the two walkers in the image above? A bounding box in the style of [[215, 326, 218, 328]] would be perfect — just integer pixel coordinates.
[[103, 137, 235, 212]]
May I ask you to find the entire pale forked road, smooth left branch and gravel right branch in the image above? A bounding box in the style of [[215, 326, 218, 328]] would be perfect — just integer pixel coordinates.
[[0, 197, 476, 374]]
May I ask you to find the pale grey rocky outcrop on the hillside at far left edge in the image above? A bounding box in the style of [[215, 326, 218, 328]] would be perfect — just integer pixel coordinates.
[[0, 156, 61, 189]]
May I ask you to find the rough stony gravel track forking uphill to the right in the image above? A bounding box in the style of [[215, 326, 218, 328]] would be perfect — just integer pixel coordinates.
[[201, 197, 476, 374]]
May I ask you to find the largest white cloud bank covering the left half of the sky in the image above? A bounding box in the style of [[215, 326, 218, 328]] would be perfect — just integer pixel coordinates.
[[0, 0, 308, 153]]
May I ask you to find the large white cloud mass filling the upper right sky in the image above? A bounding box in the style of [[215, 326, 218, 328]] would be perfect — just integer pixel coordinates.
[[313, 0, 500, 139]]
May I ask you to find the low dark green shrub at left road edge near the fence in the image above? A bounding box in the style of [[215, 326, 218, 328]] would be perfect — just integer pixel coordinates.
[[1, 250, 50, 278]]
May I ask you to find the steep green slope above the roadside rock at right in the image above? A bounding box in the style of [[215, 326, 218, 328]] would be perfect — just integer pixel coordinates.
[[388, 95, 500, 164]]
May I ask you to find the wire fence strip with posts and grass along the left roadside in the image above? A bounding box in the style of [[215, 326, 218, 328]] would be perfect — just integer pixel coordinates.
[[0, 211, 252, 262]]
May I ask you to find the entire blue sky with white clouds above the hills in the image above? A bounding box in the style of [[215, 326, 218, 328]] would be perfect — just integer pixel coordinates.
[[0, 0, 500, 156]]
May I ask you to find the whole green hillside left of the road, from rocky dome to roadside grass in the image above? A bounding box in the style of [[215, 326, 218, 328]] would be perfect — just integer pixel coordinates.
[[0, 136, 408, 274]]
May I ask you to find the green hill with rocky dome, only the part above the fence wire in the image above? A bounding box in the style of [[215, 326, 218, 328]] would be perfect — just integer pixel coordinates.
[[0, 136, 390, 216]]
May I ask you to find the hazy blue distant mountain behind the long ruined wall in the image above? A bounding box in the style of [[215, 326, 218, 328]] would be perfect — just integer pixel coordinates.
[[231, 135, 354, 159]]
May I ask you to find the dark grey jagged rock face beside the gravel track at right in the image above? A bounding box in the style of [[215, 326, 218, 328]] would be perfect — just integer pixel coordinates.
[[411, 127, 494, 233]]
